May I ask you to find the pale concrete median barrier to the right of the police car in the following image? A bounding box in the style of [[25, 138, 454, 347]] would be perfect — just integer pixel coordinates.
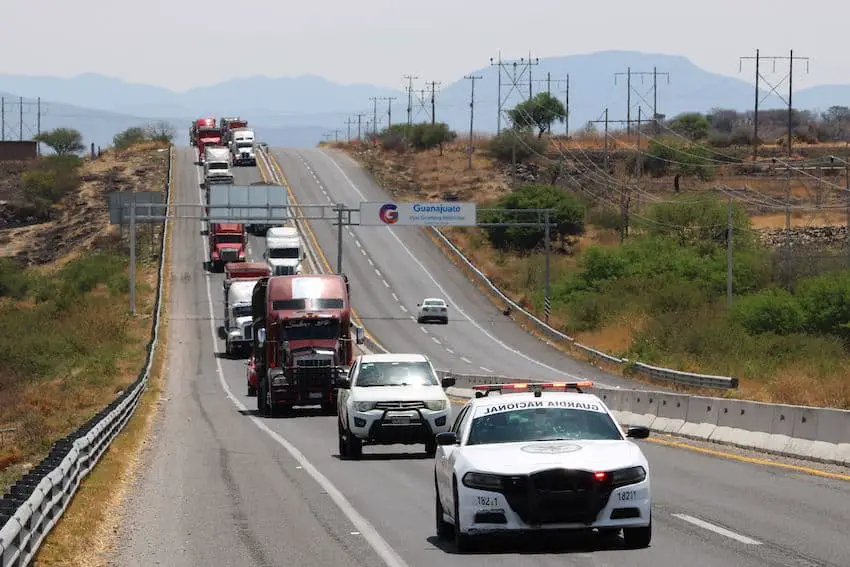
[[448, 378, 850, 466]]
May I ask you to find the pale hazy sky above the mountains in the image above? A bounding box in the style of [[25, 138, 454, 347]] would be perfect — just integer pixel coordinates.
[[0, 0, 850, 90]]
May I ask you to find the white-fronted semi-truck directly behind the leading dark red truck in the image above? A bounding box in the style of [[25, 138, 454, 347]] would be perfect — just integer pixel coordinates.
[[222, 262, 271, 356]]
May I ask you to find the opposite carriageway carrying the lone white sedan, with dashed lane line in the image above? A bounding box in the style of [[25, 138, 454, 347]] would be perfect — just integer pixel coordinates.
[[274, 145, 644, 386]]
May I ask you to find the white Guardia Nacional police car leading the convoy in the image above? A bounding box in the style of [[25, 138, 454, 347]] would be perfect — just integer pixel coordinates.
[[434, 382, 652, 551]]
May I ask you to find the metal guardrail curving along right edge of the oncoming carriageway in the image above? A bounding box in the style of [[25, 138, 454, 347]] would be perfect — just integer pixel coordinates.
[[430, 227, 738, 390]]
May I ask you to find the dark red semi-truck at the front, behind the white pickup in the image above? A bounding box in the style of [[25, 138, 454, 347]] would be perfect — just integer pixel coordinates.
[[251, 274, 363, 416]]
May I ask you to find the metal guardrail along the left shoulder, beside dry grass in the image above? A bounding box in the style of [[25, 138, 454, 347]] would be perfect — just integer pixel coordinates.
[[0, 147, 174, 567]]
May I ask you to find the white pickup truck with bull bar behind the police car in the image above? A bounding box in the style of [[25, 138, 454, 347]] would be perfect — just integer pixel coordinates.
[[337, 354, 455, 460]]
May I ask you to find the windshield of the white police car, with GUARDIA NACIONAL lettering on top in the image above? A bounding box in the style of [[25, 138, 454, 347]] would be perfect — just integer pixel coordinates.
[[466, 400, 623, 445]]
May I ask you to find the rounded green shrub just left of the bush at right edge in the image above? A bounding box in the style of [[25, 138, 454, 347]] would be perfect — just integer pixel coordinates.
[[731, 288, 806, 335]]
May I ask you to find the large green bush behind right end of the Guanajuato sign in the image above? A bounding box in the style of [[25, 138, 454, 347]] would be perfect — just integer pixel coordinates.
[[481, 185, 585, 251]]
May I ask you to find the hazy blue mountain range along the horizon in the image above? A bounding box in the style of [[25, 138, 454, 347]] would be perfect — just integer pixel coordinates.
[[0, 51, 850, 147]]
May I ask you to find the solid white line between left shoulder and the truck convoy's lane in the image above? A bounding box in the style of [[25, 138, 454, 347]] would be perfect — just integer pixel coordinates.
[[195, 160, 409, 567]]
